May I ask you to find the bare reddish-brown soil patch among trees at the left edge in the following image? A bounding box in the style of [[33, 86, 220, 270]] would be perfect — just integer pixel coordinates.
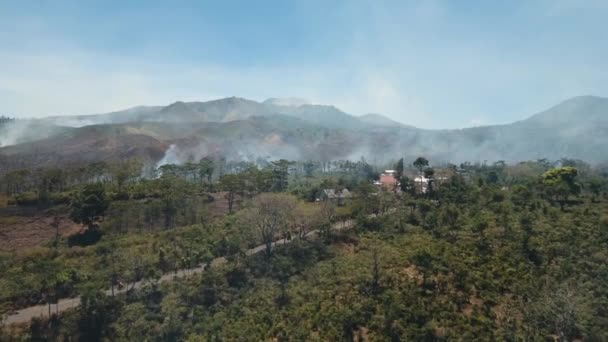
[[0, 213, 81, 251]]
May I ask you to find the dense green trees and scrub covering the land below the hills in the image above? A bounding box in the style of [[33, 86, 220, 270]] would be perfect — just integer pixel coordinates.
[[0, 157, 608, 341]]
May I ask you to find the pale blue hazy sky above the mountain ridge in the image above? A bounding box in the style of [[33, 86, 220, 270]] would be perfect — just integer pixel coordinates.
[[0, 0, 608, 128]]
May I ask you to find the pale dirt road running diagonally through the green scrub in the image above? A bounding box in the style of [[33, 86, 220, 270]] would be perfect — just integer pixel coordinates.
[[2, 220, 354, 325]]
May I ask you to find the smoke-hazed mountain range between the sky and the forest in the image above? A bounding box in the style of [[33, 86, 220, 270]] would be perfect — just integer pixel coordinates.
[[0, 96, 608, 172]]
